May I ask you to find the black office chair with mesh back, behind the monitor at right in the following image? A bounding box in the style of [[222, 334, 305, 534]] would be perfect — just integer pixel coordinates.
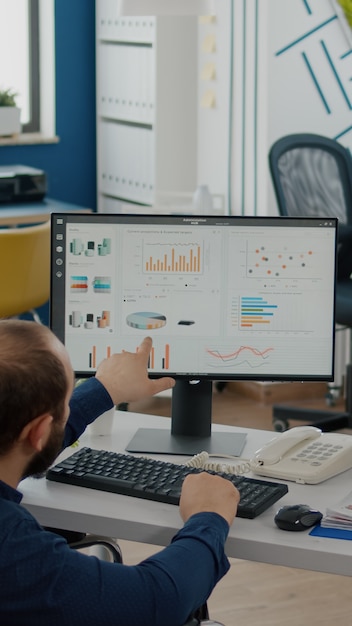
[[269, 133, 352, 431]]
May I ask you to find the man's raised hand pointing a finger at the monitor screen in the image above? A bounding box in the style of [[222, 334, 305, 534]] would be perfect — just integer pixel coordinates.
[[96, 337, 175, 404]]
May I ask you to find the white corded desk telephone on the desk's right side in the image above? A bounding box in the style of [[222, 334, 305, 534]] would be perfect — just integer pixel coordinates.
[[251, 426, 352, 485]]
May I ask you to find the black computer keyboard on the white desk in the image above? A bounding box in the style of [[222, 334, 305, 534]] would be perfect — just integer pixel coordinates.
[[46, 448, 288, 519]]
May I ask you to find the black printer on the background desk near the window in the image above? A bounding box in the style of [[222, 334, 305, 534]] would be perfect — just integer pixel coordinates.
[[0, 165, 47, 208]]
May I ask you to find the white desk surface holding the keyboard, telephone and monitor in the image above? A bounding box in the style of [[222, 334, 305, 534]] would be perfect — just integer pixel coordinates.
[[19, 411, 352, 576]]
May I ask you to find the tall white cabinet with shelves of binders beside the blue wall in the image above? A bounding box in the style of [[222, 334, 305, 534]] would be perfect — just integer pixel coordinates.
[[96, 0, 198, 212]]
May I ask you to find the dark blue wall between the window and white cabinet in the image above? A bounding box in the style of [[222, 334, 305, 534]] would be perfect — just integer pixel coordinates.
[[0, 0, 96, 209]]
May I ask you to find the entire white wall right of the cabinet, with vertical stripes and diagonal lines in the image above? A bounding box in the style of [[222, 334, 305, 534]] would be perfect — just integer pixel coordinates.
[[198, 0, 352, 215]]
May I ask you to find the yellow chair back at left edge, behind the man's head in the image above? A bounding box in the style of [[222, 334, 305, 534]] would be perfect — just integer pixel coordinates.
[[0, 221, 50, 322]]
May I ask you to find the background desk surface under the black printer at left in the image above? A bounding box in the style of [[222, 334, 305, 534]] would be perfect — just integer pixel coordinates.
[[0, 198, 92, 227]]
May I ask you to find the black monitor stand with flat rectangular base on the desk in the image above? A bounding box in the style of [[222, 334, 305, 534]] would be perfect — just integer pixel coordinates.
[[126, 380, 246, 456]]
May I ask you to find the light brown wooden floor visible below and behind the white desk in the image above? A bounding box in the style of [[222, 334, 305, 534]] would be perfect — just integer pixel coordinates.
[[120, 385, 352, 626]]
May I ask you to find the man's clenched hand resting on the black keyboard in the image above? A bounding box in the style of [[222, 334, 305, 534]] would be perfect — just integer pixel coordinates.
[[180, 472, 240, 526]]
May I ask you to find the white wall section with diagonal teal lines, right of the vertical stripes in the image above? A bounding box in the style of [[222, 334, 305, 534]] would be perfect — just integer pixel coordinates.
[[263, 0, 352, 213]]
